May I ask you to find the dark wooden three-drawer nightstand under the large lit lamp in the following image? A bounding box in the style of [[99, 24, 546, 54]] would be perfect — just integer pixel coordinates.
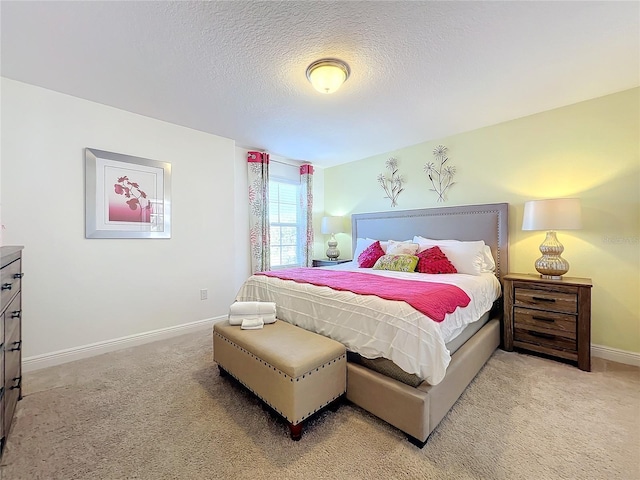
[[503, 273, 592, 372]]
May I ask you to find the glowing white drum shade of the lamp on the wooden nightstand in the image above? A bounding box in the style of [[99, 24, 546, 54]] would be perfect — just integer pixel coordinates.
[[522, 198, 582, 231]]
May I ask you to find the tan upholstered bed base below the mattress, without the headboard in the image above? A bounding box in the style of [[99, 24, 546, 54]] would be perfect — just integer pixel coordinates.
[[347, 318, 500, 448]]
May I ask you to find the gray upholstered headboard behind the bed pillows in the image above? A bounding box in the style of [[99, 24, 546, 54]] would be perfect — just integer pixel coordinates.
[[351, 203, 509, 280]]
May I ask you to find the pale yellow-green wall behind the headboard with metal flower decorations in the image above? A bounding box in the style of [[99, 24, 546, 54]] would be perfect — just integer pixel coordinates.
[[325, 88, 640, 352]]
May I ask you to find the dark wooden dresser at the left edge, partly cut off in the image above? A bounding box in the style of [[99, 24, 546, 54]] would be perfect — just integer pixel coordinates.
[[0, 247, 23, 455]]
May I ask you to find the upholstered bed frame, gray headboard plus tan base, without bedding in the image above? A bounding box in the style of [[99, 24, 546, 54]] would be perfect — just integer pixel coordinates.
[[347, 203, 509, 447]]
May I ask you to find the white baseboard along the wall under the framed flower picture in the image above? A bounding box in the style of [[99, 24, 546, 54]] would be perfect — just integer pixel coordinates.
[[22, 315, 227, 372]]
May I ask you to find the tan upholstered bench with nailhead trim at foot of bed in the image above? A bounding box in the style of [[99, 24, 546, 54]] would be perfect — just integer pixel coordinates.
[[213, 320, 347, 440]]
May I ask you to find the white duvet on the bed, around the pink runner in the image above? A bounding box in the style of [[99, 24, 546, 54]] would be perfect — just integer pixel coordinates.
[[236, 262, 501, 385]]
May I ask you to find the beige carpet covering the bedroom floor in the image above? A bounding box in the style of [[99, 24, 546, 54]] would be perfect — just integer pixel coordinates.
[[0, 331, 640, 480]]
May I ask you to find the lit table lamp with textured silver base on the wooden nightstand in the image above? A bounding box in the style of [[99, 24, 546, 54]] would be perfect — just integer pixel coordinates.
[[522, 198, 582, 280]]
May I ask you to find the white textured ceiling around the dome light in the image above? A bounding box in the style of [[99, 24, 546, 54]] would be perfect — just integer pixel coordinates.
[[0, 0, 640, 166]]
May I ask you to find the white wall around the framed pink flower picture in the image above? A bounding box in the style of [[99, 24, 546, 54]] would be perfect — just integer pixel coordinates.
[[0, 78, 239, 358]]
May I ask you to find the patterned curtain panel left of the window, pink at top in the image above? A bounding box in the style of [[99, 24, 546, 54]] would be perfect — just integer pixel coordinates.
[[247, 152, 271, 273]]
